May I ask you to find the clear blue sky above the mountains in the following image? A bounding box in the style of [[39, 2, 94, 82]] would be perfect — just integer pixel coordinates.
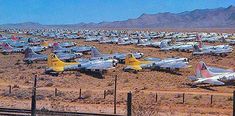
[[0, 0, 235, 24]]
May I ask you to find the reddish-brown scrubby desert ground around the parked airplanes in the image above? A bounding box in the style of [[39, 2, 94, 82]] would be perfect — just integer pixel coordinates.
[[0, 32, 235, 115]]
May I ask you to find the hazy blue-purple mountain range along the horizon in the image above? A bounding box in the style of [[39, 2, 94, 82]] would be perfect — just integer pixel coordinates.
[[0, 5, 235, 28]]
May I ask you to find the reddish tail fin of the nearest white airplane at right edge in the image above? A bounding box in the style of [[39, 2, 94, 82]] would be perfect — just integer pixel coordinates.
[[195, 61, 212, 78]]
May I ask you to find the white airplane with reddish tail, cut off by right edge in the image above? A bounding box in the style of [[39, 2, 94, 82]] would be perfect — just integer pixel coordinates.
[[189, 61, 235, 85]]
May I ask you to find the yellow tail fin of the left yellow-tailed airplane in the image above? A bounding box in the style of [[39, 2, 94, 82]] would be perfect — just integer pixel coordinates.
[[47, 53, 65, 71]]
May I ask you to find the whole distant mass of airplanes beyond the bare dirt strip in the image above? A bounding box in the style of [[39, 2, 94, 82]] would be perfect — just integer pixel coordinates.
[[5, 29, 235, 56]]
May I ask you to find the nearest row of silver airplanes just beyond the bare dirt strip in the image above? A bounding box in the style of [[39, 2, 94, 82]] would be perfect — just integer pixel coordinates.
[[85, 35, 233, 56]]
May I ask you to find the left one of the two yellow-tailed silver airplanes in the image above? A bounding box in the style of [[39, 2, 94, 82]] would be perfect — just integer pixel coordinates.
[[45, 54, 116, 77]]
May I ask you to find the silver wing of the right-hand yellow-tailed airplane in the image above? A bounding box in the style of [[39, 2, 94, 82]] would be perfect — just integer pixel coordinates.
[[160, 62, 188, 69]]
